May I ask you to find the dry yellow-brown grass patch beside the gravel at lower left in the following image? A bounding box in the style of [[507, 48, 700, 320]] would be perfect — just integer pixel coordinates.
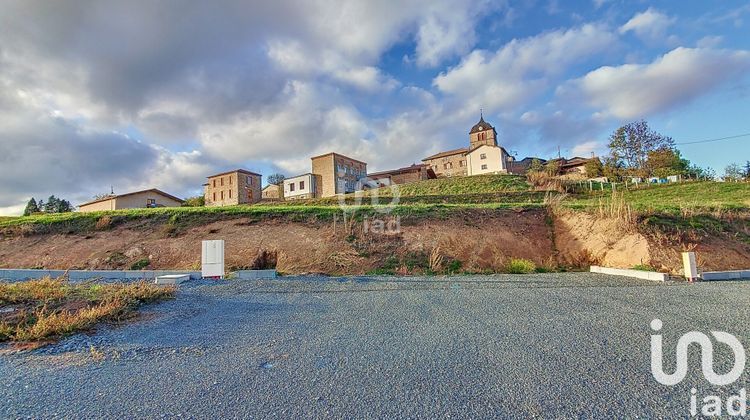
[[0, 278, 175, 344]]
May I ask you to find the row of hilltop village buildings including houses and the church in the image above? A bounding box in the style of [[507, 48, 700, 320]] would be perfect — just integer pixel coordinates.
[[78, 114, 590, 212]]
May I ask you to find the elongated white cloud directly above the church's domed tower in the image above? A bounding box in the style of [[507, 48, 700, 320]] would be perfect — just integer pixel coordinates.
[[433, 24, 615, 111]]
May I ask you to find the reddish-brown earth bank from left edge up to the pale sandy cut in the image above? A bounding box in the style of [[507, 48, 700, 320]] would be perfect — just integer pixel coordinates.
[[0, 210, 554, 274]]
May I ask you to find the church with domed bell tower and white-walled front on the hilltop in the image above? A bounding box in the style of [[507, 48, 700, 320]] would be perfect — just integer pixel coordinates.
[[422, 113, 513, 177]]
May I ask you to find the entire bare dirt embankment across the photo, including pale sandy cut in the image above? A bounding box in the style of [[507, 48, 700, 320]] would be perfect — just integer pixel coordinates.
[[0, 209, 750, 274]]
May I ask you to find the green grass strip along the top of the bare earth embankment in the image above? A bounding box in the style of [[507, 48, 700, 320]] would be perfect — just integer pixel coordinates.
[[0, 175, 750, 232]]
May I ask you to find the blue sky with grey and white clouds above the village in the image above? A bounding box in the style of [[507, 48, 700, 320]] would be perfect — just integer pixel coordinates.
[[0, 0, 750, 215]]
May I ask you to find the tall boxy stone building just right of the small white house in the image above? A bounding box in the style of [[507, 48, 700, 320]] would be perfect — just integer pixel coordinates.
[[310, 152, 367, 197]]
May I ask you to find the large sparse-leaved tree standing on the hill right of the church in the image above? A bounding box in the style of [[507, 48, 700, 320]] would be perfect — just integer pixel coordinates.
[[609, 120, 674, 176]]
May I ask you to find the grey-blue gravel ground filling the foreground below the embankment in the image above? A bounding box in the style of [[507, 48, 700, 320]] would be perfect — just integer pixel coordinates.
[[0, 273, 750, 418]]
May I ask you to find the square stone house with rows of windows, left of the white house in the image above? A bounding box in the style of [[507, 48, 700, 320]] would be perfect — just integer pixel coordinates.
[[203, 169, 262, 207]]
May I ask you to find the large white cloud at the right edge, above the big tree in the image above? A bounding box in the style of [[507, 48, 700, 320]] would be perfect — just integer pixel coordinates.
[[573, 47, 750, 118]]
